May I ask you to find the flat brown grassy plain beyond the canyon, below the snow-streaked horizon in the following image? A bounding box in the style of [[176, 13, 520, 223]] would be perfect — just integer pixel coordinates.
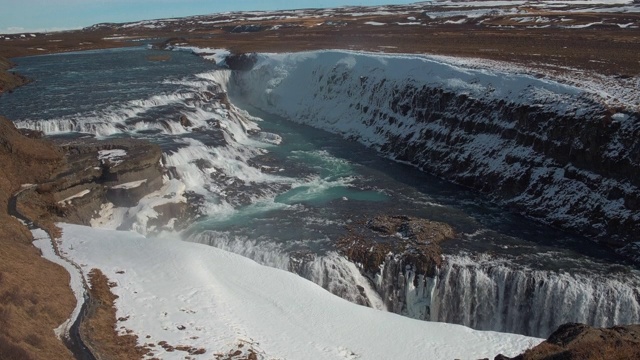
[[0, 9, 640, 76]]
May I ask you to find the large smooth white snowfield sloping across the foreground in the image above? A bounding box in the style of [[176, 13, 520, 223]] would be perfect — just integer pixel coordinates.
[[59, 224, 542, 359]]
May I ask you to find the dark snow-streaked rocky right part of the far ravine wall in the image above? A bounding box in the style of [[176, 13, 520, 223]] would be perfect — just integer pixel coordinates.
[[373, 88, 640, 252]]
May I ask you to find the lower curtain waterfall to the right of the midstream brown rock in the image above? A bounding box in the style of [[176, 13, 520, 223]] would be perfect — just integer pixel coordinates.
[[376, 256, 640, 337]]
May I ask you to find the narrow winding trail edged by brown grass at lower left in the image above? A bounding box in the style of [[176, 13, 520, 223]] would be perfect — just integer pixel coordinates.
[[7, 186, 96, 360]]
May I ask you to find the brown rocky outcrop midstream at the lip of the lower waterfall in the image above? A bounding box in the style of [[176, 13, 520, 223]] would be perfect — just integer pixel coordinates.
[[337, 215, 455, 320]]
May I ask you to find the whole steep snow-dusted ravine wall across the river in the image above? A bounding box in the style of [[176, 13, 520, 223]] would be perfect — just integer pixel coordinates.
[[230, 51, 640, 260]]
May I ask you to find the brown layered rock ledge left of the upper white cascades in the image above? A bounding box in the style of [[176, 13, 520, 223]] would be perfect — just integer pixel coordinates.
[[18, 139, 163, 225]]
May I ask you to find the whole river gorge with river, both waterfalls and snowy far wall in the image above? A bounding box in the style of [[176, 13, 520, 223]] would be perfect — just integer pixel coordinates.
[[0, 47, 640, 337]]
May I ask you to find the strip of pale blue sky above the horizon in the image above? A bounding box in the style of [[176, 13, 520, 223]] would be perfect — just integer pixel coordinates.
[[0, 0, 417, 33]]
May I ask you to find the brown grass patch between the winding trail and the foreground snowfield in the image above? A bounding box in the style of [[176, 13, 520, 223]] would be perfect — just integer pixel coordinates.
[[80, 269, 146, 360]]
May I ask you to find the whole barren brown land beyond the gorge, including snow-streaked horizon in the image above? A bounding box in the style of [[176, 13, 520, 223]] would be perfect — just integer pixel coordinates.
[[0, 5, 640, 77]]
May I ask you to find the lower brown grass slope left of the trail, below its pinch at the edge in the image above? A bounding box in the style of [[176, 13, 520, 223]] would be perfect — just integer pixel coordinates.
[[0, 232, 75, 359]]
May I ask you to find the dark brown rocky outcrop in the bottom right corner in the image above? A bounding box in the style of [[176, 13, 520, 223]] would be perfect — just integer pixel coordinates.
[[502, 323, 640, 360]]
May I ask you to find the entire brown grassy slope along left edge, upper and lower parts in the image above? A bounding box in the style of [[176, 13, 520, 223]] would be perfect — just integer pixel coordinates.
[[0, 118, 75, 359]]
